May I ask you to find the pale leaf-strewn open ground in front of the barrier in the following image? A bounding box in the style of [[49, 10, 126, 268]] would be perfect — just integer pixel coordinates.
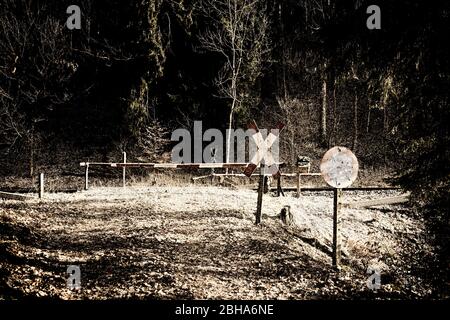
[[0, 185, 431, 299]]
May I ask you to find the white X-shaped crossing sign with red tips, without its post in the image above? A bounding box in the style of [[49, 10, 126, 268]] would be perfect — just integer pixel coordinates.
[[244, 121, 284, 178]]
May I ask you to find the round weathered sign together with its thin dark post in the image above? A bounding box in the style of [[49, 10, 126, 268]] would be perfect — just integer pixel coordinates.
[[320, 147, 359, 267]]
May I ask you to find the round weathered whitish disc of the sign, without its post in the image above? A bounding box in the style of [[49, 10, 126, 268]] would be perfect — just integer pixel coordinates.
[[320, 147, 359, 189]]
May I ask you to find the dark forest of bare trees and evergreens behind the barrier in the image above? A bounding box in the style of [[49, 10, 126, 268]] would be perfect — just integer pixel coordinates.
[[0, 0, 450, 297]]
